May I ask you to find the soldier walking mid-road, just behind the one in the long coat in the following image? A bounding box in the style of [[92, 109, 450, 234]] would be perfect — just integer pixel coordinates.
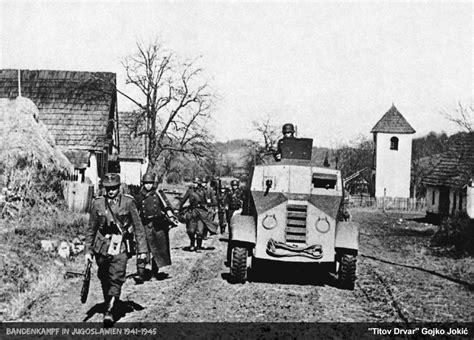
[[178, 178, 217, 252]]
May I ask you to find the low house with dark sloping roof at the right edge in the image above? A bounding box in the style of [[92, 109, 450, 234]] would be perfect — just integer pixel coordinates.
[[423, 132, 474, 218]]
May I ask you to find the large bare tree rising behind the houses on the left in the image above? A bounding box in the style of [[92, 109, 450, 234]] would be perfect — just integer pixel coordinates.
[[101, 40, 214, 177]]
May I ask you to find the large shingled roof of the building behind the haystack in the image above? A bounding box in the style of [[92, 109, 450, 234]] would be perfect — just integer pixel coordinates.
[[0, 69, 116, 151]]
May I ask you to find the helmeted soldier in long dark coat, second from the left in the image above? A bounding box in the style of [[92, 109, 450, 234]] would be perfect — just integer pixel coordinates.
[[135, 173, 171, 284]]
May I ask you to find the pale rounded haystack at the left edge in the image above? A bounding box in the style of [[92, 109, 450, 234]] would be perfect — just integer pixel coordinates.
[[0, 97, 74, 172]]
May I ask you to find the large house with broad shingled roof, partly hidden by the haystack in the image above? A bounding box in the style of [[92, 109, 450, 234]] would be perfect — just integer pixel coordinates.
[[0, 69, 119, 187]]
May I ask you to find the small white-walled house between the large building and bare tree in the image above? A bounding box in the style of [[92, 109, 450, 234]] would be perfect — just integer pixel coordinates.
[[118, 112, 148, 185]]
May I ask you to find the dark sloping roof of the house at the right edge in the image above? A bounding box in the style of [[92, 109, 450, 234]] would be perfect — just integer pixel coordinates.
[[423, 132, 474, 189]]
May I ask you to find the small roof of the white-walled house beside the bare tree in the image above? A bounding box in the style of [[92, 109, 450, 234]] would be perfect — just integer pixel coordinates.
[[118, 112, 146, 161]]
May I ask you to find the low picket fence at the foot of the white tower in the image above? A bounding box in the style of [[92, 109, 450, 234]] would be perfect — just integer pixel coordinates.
[[349, 196, 426, 211]]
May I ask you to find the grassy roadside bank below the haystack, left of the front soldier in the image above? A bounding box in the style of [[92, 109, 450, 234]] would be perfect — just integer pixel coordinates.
[[0, 208, 87, 321]]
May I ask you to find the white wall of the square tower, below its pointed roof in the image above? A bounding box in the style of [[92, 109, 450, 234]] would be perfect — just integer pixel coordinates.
[[375, 133, 412, 198]]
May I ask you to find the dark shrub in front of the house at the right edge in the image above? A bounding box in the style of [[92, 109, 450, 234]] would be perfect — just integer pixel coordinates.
[[431, 212, 474, 256]]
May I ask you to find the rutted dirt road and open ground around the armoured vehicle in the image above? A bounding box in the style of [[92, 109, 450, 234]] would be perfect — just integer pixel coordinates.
[[23, 211, 474, 323]]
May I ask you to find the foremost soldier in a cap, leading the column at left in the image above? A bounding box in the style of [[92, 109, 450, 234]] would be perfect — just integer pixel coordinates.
[[85, 173, 147, 327]]
